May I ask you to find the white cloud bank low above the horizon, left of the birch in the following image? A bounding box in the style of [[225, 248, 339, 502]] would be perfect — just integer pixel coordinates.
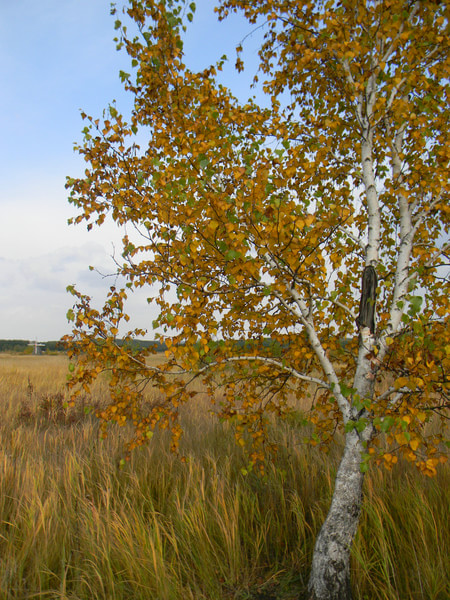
[[0, 243, 160, 340]]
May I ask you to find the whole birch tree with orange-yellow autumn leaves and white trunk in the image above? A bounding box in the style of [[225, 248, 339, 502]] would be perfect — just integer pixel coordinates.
[[68, 0, 450, 600]]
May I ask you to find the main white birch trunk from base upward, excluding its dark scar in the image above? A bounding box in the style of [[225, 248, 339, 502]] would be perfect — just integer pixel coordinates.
[[308, 80, 381, 600]]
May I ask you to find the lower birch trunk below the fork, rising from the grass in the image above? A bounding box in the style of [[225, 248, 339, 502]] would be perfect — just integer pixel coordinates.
[[308, 430, 364, 600]]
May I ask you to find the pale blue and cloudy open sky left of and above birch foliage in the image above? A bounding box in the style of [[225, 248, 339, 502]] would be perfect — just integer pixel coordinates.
[[0, 0, 256, 341]]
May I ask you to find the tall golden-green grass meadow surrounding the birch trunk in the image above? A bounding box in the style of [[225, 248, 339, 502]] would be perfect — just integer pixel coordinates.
[[0, 354, 450, 600]]
